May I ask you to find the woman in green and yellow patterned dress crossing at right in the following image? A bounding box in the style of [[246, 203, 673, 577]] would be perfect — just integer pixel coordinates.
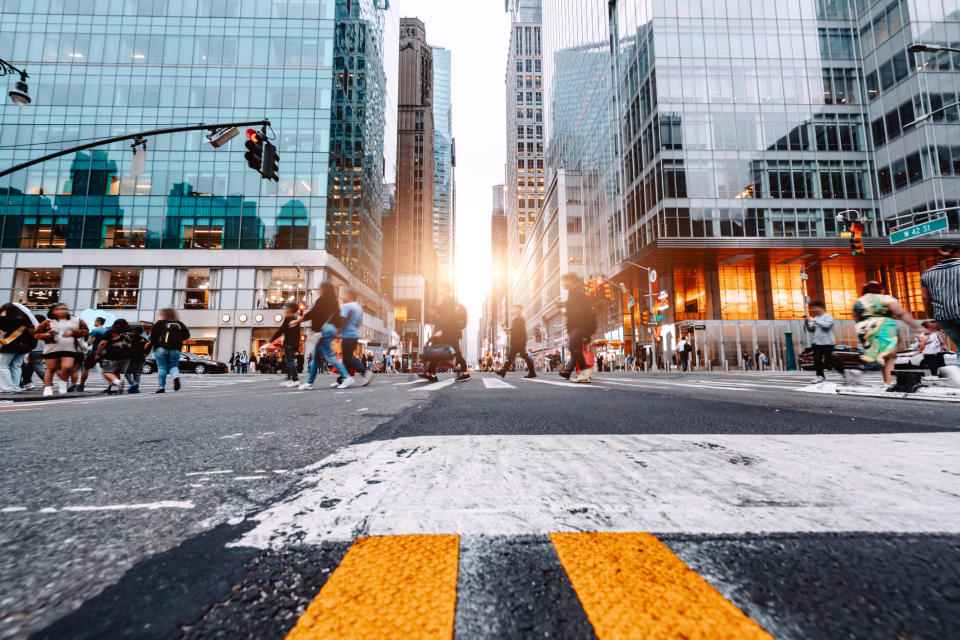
[[853, 280, 921, 391]]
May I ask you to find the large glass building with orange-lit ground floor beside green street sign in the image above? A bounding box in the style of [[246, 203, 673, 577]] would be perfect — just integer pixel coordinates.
[[528, 0, 960, 366]]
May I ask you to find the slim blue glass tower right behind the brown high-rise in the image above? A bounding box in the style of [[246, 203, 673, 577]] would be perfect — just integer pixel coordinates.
[[433, 47, 456, 293]]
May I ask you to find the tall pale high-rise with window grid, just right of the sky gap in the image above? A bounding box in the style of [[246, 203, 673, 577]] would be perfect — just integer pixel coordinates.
[[505, 0, 545, 273]]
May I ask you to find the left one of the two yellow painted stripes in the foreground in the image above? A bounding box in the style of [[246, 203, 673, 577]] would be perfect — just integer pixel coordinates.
[[287, 535, 460, 640]]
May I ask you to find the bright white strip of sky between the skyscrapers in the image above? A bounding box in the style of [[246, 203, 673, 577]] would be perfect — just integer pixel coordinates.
[[393, 0, 510, 360]]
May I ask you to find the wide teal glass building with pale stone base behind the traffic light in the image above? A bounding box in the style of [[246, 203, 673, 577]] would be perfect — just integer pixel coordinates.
[[0, 0, 392, 358]]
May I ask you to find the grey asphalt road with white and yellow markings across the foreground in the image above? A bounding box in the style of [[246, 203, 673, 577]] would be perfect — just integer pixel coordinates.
[[0, 374, 960, 638]]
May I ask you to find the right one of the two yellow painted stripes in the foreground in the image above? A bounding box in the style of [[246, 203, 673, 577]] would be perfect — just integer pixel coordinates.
[[550, 533, 772, 640]]
